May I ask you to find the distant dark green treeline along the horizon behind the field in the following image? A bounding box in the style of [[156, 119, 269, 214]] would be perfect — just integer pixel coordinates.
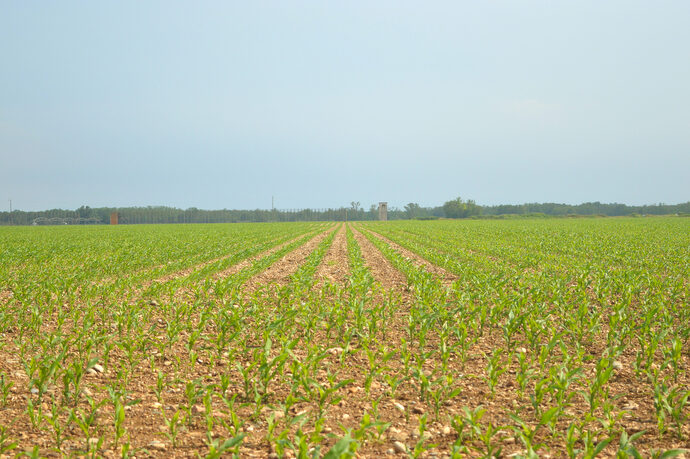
[[0, 198, 690, 225]]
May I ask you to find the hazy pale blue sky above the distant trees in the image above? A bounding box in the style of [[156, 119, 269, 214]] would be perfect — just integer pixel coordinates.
[[0, 0, 690, 210]]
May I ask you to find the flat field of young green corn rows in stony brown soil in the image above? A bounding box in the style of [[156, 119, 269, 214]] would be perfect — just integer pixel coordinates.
[[0, 217, 690, 458]]
